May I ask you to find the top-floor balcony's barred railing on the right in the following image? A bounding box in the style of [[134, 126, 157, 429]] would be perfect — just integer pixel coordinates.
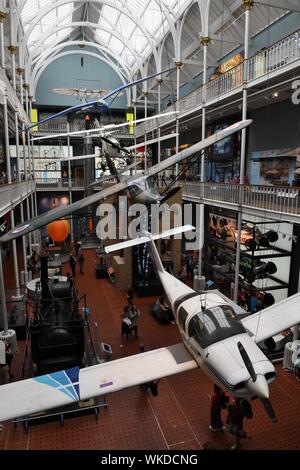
[[136, 30, 300, 137]]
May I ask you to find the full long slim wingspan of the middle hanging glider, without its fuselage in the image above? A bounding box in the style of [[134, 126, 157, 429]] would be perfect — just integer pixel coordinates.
[[0, 119, 252, 242]]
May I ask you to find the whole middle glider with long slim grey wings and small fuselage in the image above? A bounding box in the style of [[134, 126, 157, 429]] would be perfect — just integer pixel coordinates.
[[0, 119, 252, 242]]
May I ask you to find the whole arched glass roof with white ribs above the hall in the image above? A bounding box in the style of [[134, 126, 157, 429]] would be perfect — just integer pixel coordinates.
[[13, 0, 292, 97]]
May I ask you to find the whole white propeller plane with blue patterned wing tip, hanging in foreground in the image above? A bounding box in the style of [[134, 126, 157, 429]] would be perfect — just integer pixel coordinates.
[[0, 225, 300, 422]]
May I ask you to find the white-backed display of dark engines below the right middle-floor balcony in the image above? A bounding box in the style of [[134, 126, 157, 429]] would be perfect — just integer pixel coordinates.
[[205, 213, 293, 312]]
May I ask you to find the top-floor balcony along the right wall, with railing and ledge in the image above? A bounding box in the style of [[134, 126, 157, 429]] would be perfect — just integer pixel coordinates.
[[135, 30, 300, 138]]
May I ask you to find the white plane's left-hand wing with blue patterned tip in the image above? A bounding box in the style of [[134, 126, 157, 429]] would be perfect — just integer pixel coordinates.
[[0, 343, 198, 422]]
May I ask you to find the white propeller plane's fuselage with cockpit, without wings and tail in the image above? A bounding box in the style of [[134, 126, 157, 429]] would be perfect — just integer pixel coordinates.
[[159, 272, 276, 399]]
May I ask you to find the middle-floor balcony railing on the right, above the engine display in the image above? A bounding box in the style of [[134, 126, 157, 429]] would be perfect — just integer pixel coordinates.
[[183, 183, 300, 216]]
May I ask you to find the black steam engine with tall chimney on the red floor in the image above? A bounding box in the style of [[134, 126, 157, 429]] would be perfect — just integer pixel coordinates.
[[30, 255, 85, 375]]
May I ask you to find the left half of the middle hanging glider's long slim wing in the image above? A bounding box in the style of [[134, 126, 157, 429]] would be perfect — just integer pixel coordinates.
[[0, 182, 128, 242]]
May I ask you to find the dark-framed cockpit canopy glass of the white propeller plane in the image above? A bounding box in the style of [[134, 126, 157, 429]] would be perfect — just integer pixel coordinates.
[[188, 305, 246, 349]]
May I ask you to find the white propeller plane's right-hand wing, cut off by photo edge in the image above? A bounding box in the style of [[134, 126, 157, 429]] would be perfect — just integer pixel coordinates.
[[241, 292, 300, 343]]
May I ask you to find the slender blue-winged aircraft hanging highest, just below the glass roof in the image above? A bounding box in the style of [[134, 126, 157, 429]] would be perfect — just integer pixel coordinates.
[[24, 67, 176, 131]]
